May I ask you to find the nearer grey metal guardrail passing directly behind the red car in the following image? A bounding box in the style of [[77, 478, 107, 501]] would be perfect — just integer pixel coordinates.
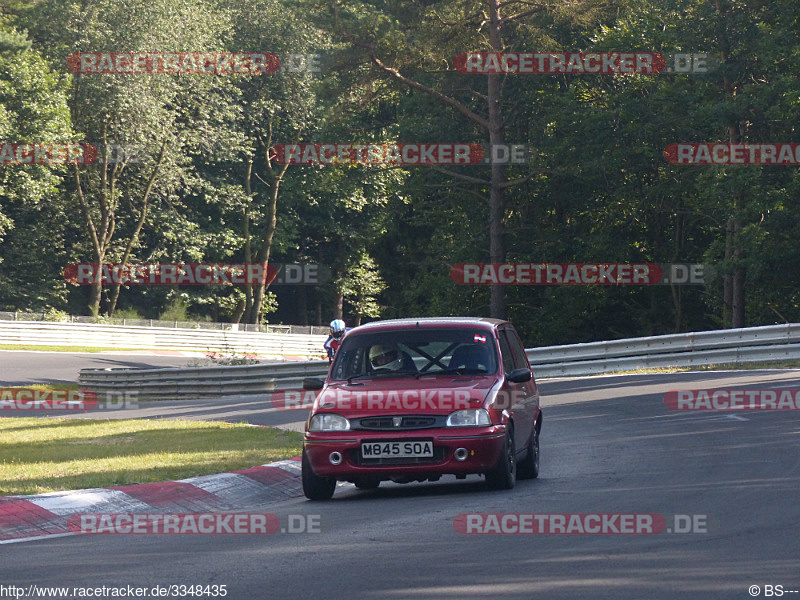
[[80, 323, 800, 399]]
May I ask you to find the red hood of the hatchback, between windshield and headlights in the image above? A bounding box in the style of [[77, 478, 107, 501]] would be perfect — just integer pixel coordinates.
[[312, 375, 498, 418]]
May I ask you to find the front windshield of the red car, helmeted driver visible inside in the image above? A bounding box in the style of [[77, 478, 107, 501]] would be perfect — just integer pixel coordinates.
[[331, 327, 498, 380]]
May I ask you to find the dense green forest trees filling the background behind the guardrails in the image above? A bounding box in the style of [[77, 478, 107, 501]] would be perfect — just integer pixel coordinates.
[[0, 0, 800, 346]]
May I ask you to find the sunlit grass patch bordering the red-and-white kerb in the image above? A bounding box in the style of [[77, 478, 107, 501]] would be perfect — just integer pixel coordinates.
[[0, 417, 302, 495]]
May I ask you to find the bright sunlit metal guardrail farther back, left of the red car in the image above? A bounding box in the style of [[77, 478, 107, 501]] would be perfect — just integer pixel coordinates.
[[0, 321, 326, 358]]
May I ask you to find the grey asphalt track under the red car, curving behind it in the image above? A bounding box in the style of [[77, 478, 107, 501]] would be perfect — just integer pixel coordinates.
[[0, 371, 800, 600]]
